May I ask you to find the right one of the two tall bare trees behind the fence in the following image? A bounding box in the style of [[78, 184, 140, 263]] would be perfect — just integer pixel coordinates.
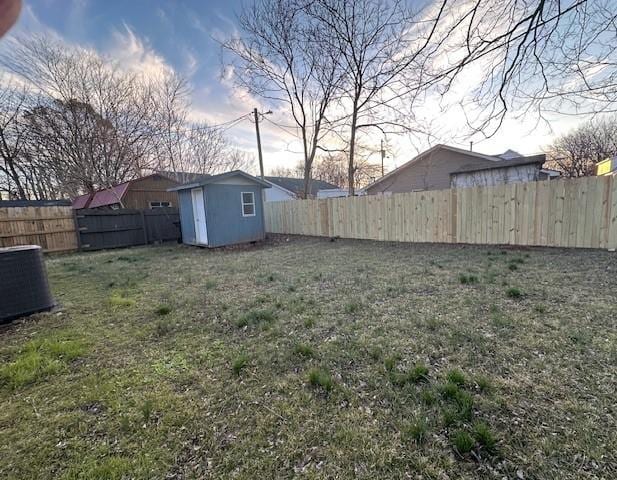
[[307, 0, 440, 195]]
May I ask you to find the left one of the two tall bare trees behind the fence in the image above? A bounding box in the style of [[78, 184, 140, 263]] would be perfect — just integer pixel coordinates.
[[223, 0, 340, 196]]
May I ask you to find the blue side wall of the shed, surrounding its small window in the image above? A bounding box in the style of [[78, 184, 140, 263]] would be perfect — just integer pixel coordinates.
[[204, 183, 265, 247]]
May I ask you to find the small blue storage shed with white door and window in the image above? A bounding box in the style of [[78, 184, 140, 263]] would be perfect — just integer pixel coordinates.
[[169, 170, 270, 247]]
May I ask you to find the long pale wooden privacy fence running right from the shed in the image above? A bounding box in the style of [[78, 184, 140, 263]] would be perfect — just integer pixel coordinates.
[[265, 177, 617, 249]]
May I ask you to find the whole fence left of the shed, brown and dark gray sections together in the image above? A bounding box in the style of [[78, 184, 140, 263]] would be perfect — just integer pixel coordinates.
[[0, 206, 180, 252]]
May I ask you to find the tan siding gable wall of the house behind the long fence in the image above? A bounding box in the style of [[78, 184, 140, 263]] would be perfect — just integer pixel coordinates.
[[366, 149, 494, 195]]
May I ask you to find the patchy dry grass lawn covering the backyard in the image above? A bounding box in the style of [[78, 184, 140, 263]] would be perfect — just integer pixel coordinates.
[[0, 238, 617, 480]]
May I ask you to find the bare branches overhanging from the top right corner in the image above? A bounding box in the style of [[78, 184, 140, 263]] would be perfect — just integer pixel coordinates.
[[414, 0, 617, 137]]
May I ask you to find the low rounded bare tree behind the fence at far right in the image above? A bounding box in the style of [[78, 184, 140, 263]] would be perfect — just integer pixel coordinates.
[[548, 117, 617, 177]]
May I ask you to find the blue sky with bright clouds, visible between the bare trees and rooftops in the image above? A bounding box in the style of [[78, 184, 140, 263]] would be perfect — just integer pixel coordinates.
[[3, 0, 577, 173]]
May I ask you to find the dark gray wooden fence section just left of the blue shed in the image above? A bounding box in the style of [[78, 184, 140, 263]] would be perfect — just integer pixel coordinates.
[[75, 208, 180, 250]]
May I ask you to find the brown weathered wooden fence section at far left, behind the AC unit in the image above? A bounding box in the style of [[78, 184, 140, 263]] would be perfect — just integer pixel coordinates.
[[0, 206, 77, 252]]
